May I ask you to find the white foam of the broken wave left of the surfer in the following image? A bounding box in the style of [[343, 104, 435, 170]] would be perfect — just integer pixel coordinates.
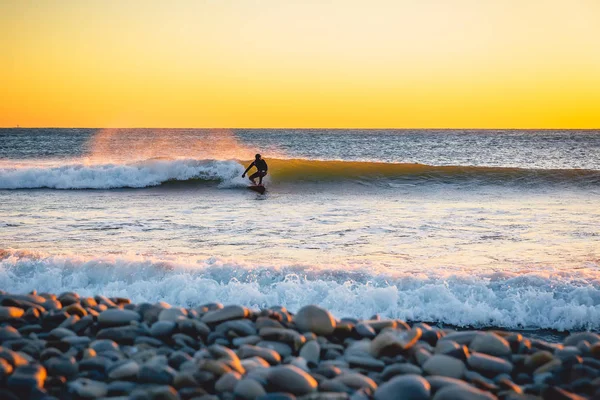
[[0, 159, 244, 189]]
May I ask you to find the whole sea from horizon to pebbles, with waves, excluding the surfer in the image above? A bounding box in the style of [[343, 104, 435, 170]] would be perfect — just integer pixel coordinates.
[[0, 129, 600, 330]]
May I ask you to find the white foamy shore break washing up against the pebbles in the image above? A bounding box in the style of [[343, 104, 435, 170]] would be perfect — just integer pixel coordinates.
[[0, 251, 600, 330]]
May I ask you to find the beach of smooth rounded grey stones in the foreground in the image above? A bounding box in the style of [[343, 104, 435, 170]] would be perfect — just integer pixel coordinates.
[[0, 291, 600, 400]]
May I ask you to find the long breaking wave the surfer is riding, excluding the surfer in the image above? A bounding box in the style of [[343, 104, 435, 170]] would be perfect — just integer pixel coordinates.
[[0, 158, 600, 189]]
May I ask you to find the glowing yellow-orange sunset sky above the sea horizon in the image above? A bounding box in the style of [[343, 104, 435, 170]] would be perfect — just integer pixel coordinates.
[[0, 0, 600, 128]]
